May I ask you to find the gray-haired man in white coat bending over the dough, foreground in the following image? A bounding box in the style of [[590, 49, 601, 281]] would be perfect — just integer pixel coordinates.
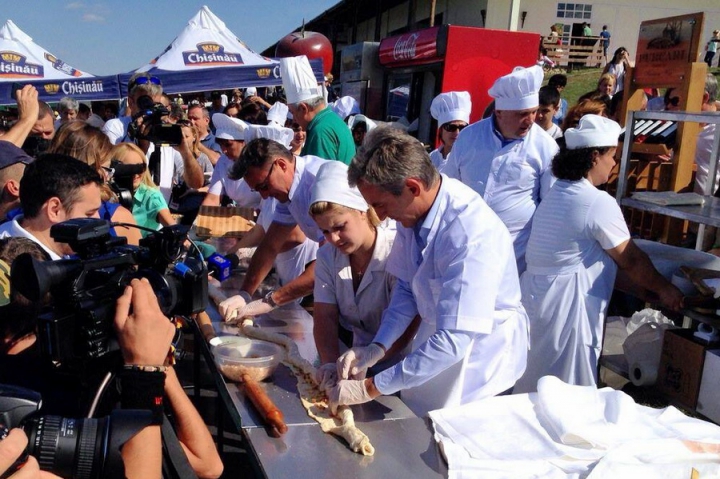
[[328, 127, 528, 415]]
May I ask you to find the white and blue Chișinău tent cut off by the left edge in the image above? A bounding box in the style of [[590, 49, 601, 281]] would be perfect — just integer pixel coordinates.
[[0, 20, 120, 104]]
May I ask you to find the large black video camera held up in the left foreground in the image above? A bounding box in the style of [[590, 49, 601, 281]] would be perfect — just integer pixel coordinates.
[[11, 218, 208, 369]]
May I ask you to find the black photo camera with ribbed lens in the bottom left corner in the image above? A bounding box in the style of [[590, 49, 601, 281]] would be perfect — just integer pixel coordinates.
[[0, 384, 152, 479]]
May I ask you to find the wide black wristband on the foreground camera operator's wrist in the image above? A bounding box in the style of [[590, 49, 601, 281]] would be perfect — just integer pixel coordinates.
[[120, 366, 165, 426]]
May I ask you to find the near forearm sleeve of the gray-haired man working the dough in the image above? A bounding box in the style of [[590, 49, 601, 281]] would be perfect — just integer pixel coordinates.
[[373, 329, 476, 394]]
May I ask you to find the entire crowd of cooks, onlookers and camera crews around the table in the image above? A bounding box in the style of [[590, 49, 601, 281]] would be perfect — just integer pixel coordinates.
[[0, 45, 717, 478]]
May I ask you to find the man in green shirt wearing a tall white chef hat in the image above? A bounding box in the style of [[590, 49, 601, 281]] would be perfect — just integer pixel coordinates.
[[280, 56, 355, 165]]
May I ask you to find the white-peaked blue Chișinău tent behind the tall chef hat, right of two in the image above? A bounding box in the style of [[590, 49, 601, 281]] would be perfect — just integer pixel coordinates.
[[119, 6, 323, 96]]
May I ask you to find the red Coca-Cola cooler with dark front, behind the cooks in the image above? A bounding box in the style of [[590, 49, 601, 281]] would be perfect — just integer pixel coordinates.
[[378, 25, 540, 144]]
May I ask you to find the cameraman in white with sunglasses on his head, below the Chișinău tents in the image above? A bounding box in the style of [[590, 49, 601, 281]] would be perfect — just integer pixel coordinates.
[[102, 72, 204, 201]]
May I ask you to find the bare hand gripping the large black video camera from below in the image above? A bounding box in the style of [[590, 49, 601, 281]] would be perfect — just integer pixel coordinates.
[[115, 278, 175, 366]]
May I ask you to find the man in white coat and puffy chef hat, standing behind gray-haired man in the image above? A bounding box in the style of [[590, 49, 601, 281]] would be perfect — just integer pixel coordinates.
[[443, 66, 558, 274]]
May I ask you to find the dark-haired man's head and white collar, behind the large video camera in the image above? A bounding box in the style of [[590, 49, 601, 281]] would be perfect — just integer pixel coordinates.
[[0, 154, 102, 260]]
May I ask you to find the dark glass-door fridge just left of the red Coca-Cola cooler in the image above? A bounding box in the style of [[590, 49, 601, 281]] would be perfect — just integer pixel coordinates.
[[340, 42, 384, 119]]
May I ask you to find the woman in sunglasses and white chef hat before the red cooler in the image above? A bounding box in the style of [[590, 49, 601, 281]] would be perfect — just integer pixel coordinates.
[[430, 91, 472, 173]]
